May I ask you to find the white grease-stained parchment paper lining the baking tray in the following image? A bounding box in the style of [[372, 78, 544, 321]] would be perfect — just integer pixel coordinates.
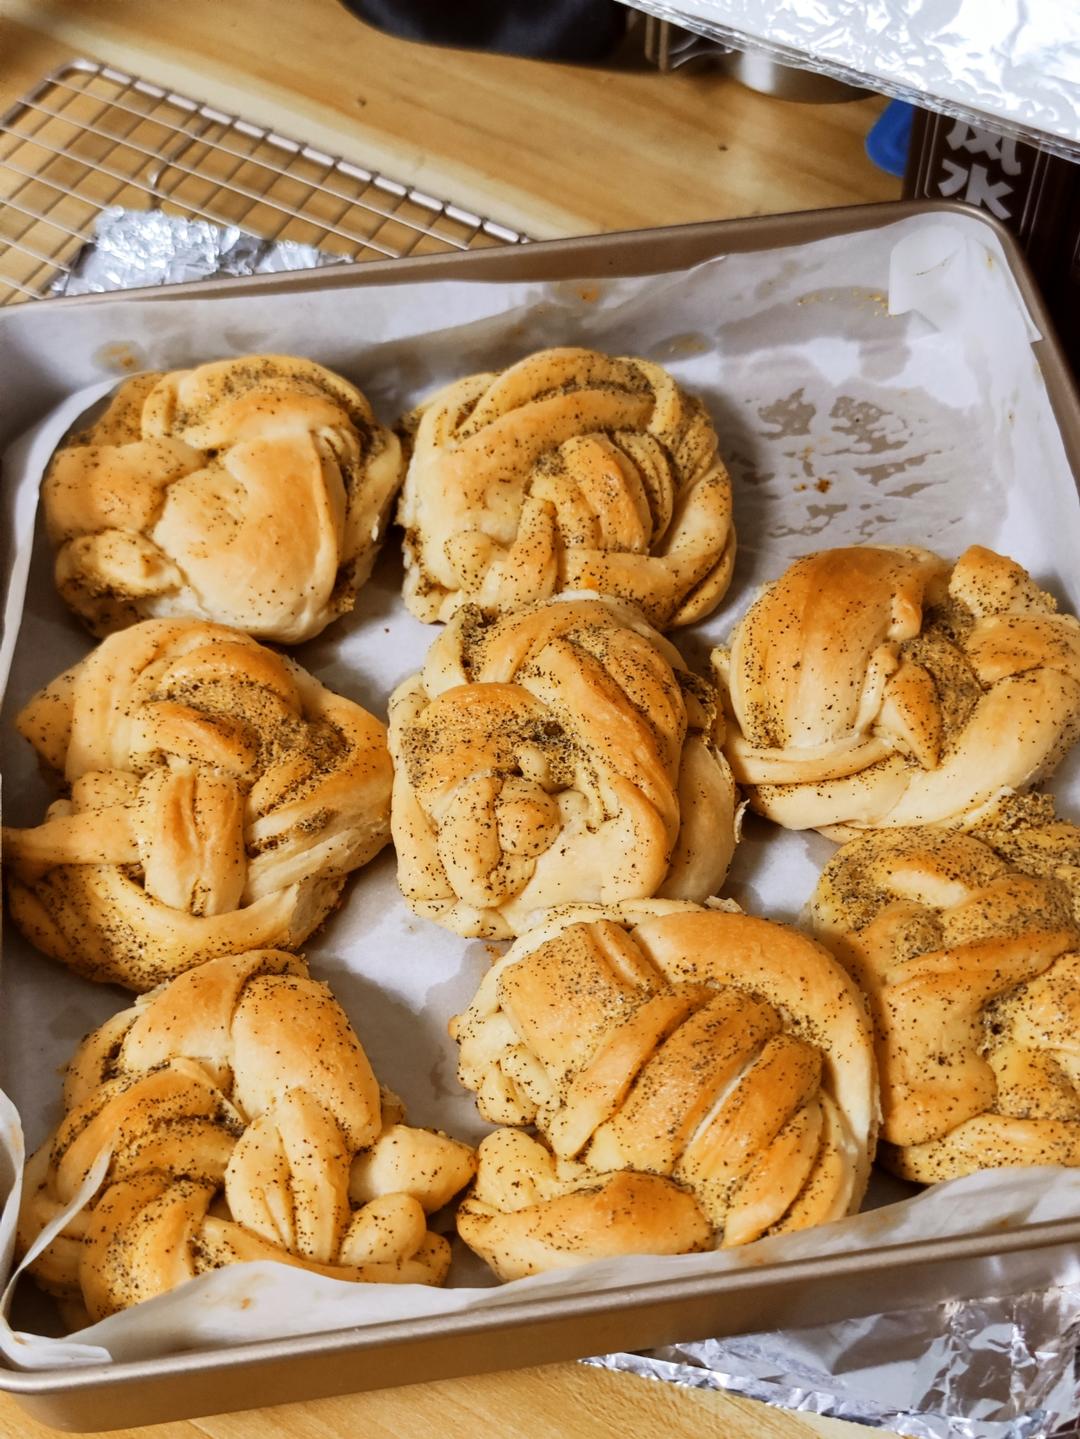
[[0, 217, 1080, 1367]]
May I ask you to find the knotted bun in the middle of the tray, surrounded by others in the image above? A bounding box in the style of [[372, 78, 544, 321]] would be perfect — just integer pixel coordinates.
[[390, 597, 735, 938]]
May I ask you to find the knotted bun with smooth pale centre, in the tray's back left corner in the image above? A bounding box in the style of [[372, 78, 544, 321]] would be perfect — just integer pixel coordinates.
[[42, 355, 401, 643]]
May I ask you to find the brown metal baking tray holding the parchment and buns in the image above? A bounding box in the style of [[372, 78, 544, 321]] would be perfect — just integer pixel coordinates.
[[0, 201, 1080, 1432]]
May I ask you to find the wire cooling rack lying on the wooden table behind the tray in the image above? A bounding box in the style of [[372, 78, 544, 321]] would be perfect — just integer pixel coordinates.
[[0, 59, 525, 305]]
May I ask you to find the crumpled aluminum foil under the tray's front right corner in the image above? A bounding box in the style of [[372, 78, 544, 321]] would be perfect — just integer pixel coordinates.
[[585, 1288, 1080, 1439]]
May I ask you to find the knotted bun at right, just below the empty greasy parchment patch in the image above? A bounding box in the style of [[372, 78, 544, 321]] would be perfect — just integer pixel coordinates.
[[713, 545, 1080, 839]]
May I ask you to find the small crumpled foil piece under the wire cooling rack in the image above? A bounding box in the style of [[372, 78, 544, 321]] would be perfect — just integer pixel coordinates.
[[52, 206, 345, 295]]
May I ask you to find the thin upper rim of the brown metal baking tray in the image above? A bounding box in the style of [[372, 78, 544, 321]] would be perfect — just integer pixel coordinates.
[[0, 201, 1080, 1425]]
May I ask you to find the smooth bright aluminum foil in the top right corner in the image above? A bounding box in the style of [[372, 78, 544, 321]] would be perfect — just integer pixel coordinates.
[[624, 0, 1080, 160]]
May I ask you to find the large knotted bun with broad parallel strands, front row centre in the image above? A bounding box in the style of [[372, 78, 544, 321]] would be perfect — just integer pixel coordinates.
[[450, 901, 877, 1279]]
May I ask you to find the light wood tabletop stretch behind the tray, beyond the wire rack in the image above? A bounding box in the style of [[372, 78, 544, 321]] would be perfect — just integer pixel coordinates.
[[0, 0, 900, 239]]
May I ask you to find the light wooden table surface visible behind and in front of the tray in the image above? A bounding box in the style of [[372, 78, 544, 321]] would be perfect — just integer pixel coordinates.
[[0, 0, 899, 1439]]
